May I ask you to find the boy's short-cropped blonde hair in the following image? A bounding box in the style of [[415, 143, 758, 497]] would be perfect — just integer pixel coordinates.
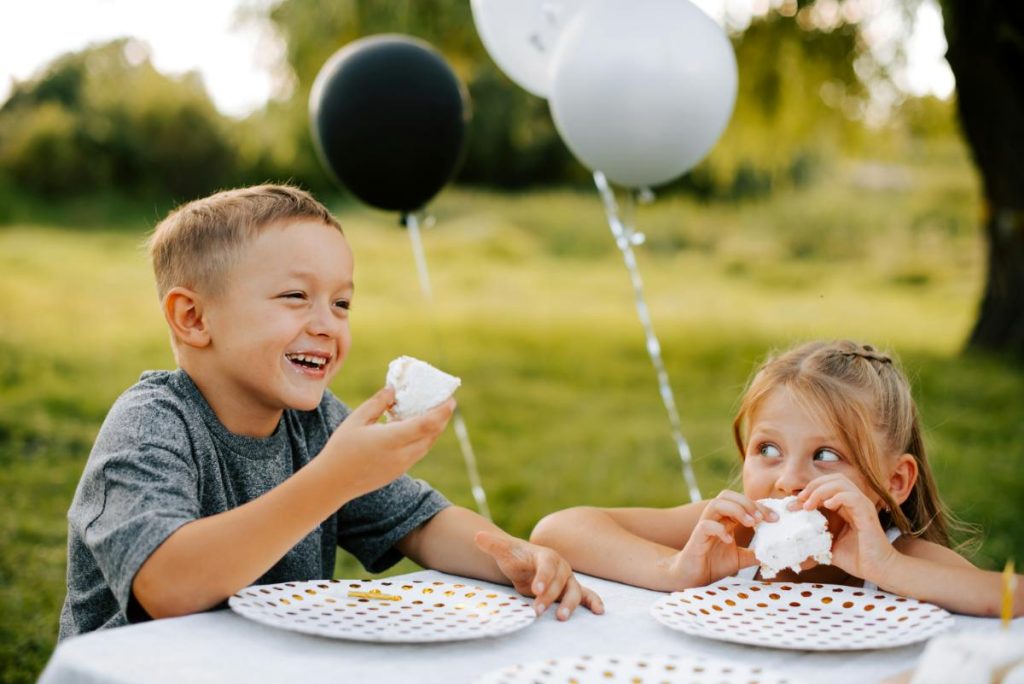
[[148, 184, 341, 300]]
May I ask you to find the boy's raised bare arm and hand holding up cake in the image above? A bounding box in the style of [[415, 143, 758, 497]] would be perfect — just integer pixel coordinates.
[[132, 389, 455, 617]]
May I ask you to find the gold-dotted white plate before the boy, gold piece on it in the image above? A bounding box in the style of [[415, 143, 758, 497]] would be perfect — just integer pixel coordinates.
[[227, 580, 537, 643]]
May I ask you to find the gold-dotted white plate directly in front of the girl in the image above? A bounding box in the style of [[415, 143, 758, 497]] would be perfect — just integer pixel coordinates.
[[651, 582, 953, 650]]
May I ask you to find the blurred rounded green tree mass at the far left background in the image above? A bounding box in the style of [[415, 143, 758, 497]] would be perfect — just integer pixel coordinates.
[[0, 39, 237, 200]]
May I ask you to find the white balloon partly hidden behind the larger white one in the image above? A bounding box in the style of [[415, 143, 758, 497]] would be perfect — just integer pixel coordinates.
[[472, 0, 585, 97]]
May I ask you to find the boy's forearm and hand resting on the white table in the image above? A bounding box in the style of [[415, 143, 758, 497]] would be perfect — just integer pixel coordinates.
[[396, 506, 604, 619]]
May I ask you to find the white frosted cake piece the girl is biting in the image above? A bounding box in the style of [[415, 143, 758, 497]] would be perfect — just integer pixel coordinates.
[[751, 497, 831, 580]]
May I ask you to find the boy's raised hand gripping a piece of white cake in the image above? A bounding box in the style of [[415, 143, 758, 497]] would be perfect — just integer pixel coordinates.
[[325, 387, 455, 496]]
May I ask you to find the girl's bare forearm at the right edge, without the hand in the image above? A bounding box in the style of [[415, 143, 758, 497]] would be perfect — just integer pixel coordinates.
[[865, 538, 1024, 617]]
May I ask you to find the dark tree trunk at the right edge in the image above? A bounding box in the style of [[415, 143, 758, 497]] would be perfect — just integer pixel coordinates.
[[942, 0, 1024, 357]]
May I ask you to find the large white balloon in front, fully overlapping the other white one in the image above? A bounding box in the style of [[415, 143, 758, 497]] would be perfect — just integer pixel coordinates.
[[550, 0, 737, 187]]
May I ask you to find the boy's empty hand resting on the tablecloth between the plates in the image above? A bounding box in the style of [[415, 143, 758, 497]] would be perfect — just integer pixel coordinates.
[[473, 531, 604, 619]]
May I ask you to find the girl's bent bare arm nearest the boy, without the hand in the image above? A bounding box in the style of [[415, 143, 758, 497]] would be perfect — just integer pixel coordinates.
[[529, 502, 707, 591]]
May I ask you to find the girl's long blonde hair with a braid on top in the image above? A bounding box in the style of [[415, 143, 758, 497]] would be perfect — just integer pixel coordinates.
[[732, 340, 950, 547]]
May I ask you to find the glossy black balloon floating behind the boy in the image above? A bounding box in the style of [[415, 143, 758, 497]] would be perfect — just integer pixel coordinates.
[[309, 35, 469, 212]]
